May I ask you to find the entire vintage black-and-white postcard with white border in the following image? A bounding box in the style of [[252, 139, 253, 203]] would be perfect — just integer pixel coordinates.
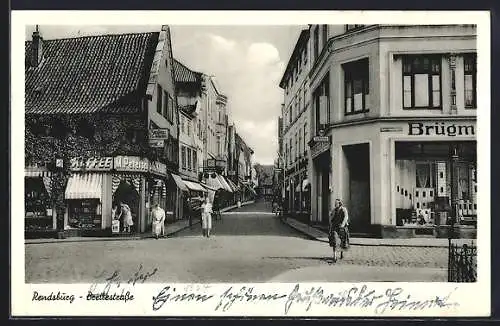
[[10, 11, 491, 317]]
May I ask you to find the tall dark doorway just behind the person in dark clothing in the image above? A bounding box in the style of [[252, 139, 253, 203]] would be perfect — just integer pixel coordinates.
[[342, 143, 371, 233]]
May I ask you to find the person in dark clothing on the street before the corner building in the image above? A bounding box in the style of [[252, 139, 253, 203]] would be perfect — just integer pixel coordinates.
[[328, 198, 349, 262]]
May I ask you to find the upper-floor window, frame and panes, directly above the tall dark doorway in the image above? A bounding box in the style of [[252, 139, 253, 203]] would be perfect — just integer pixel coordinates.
[[342, 59, 370, 115]]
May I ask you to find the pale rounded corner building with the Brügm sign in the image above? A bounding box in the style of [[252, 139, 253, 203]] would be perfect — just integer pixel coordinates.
[[309, 25, 477, 237]]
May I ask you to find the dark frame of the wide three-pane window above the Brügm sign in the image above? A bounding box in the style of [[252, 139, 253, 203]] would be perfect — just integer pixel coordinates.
[[401, 54, 443, 111]]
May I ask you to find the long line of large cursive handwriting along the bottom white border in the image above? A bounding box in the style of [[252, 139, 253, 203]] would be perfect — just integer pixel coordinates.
[[152, 284, 458, 315]]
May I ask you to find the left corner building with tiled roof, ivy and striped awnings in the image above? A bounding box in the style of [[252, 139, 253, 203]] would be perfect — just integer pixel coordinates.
[[25, 26, 178, 234]]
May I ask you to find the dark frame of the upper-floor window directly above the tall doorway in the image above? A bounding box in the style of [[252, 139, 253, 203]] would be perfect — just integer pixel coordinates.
[[342, 58, 370, 116]]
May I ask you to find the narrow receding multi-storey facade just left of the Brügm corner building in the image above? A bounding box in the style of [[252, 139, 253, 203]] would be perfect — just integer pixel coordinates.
[[278, 29, 311, 216]]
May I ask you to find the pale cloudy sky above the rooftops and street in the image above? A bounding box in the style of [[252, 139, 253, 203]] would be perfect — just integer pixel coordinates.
[[26, 25, 307, 164]]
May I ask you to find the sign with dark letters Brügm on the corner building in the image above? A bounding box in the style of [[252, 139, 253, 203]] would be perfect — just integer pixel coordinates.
[[408, 122, 476, 137]]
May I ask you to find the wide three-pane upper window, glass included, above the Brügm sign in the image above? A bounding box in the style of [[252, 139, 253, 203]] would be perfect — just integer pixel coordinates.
[[403, 55, 441, 109]]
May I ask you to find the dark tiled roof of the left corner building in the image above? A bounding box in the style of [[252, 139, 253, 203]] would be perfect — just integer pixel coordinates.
[[25, 32, 159, 114]]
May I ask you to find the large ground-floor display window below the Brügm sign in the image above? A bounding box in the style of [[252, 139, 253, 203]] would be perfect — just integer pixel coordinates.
[[394, 141, 477, 226]]
